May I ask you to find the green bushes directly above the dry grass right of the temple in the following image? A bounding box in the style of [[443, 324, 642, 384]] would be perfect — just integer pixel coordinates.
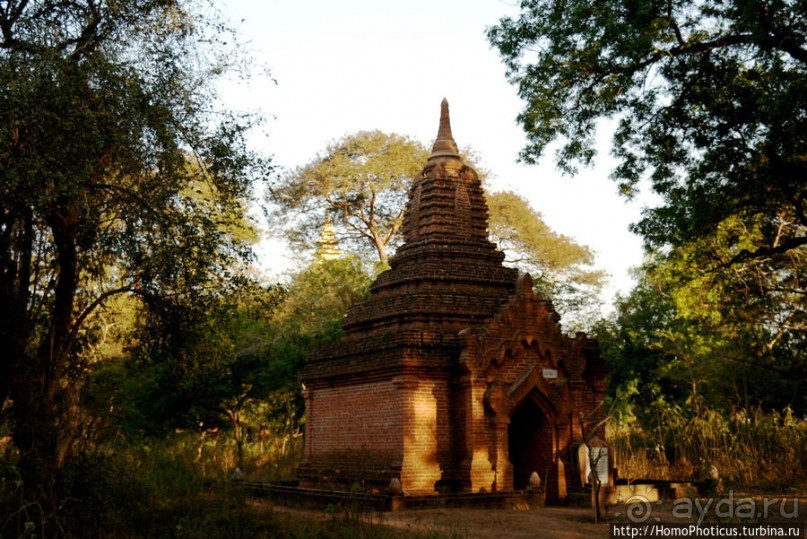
[[596, 274, 807, 429]]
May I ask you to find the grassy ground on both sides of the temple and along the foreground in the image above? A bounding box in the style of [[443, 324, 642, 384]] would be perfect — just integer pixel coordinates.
[[0, 418, 807, 539]]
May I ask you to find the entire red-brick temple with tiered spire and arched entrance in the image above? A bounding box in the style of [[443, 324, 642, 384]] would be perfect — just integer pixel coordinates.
[[298, 100, 606, 500]]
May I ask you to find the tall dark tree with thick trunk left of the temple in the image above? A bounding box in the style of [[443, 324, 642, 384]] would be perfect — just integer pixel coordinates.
[[0, 0, 270, 517]]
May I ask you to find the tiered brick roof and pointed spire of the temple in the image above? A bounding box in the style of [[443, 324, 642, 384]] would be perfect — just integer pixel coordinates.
[[303, 99, 518, 380]]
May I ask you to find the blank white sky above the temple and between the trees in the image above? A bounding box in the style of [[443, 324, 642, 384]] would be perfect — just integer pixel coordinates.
[[218, 0, 642, 310]]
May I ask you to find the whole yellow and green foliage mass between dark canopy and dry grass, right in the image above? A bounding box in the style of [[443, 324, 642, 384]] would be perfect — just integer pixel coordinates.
[[598, 219, 807, 448]]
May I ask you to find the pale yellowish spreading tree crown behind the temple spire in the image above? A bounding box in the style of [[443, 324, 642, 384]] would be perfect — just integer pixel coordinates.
[[269, 131, 603, 324]]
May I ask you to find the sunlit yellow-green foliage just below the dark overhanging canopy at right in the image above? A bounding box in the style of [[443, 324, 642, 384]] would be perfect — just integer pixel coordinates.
[[647, 218, 807, 400]]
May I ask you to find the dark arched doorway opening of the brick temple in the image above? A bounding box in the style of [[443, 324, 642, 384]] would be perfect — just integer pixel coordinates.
[[507, 389, 555, 490]]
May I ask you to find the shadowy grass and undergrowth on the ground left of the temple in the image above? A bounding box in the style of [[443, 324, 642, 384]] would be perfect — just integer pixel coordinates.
[[0, 434, 454, 539]]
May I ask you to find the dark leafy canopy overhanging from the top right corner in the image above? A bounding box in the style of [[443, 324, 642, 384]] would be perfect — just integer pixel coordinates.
[[488, 0, 807, 262]]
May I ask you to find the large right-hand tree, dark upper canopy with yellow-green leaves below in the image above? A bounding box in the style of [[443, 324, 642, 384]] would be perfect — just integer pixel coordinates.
[[488, 0, 807, 378]]
